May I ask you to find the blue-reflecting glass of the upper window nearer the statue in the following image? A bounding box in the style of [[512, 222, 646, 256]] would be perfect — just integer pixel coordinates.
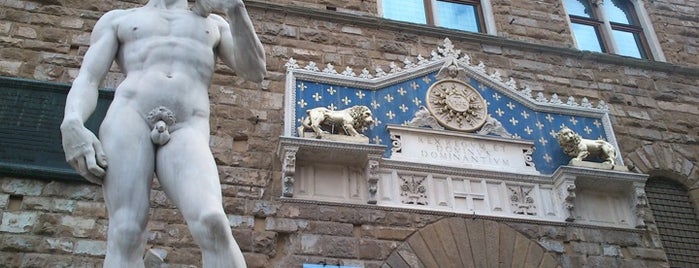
[[380, 0, 486, 33]]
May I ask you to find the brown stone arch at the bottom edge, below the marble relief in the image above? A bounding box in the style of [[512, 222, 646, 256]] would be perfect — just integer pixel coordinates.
[[381, 218, 561, 268]]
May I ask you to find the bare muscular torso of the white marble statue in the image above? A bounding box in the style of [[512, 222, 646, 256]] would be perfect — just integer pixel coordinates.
[[104, 7, 220, 125]]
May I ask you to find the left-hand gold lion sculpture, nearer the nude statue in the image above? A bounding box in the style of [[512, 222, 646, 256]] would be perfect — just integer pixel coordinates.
[[298, 105, 374, 139]]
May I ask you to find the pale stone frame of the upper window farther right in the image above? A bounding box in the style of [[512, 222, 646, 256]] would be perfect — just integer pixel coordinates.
[[562, 0, 665, 61]]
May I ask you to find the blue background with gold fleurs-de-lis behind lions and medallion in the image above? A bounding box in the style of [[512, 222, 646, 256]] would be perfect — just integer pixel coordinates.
[[295, 72, 605, 174]]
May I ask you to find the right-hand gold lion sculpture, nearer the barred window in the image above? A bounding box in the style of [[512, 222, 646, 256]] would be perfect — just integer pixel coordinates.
[[558, 127, 617, 166]]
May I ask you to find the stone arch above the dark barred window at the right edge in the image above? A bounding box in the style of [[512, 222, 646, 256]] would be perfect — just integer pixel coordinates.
[[625, 143, 699, 190]]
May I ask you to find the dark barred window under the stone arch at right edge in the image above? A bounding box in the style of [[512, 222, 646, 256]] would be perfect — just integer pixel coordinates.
[[645, 177, 699, 267]]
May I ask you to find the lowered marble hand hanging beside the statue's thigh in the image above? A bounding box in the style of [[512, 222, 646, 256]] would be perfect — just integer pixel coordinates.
[[61, 123, 107, 184]]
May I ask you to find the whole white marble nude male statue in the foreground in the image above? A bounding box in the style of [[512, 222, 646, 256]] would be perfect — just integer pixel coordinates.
[[61, 0, 266, 267]]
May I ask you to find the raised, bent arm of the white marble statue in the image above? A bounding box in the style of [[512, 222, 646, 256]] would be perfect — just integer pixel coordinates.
[[212, 1, 267, 82]]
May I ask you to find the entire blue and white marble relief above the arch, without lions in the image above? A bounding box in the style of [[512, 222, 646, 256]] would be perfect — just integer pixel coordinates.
[[278, 39, 647, 228]]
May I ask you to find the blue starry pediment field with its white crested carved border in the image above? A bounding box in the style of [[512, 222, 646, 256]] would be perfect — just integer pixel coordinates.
[[284, 39, 621, 174]]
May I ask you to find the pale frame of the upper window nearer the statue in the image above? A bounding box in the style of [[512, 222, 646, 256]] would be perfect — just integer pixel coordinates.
[[378, 0, 497, 35]]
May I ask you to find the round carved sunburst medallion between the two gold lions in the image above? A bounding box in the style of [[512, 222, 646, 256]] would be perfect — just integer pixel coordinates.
[[427, 79, 488, 132]]
